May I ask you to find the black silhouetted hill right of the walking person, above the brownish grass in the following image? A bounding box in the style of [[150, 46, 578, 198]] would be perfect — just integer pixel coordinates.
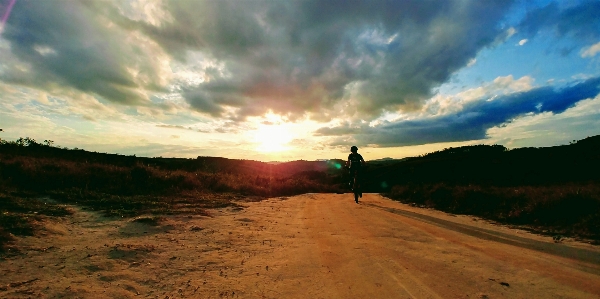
[[360, 136, 600, 192]]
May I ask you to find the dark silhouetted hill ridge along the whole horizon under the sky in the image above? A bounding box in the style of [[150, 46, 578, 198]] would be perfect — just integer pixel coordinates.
[[0, 135, 600, 192]]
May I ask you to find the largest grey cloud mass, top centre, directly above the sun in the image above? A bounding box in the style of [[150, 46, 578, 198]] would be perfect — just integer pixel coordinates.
[[116, 0, 512, 121]]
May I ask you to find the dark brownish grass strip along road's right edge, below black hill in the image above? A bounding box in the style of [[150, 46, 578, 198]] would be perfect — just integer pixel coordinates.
[[385, 182, 600, 243]]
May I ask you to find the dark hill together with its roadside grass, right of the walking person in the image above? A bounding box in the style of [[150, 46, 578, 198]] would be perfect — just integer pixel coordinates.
[[366, 136, 600, 240]]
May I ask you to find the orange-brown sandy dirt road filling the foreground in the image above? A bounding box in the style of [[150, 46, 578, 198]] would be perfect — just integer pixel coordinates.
[[0, 194, 600, 298]]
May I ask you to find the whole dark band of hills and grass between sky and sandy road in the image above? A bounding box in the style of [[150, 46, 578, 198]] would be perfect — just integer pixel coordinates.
[[0, 136, 600, 250]]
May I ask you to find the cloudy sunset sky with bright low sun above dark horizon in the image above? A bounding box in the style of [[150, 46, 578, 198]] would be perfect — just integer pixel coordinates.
[[0, 0, 600, 161]]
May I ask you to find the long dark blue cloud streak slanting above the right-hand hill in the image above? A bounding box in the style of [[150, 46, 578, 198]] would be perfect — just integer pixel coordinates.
[[316, 77, 600, 147]]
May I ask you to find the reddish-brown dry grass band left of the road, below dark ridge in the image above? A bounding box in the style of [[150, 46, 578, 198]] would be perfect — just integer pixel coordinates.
[[0, 156, 333, 197]]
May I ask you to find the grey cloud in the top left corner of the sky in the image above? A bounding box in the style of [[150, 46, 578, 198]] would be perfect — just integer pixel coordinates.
[[0, 0, 162, 105]]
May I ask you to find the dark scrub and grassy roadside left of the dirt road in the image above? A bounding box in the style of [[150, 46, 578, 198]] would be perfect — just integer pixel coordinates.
[[0, 139, 338, 251]]
